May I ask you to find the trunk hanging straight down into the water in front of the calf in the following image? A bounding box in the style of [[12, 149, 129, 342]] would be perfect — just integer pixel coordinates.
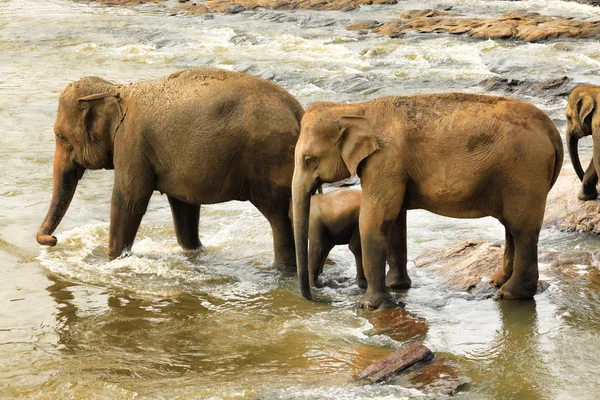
[[292, 167, 312, 300]]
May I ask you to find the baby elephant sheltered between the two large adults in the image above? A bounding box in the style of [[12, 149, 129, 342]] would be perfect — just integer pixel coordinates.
[[290, 189, 410, 289]]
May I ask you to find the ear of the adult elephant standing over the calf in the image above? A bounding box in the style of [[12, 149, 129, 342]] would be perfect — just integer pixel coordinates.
[[336, 115, 379, 175]]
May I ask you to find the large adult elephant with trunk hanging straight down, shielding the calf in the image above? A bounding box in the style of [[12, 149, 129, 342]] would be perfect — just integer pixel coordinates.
[[292, 93, 563, 307]]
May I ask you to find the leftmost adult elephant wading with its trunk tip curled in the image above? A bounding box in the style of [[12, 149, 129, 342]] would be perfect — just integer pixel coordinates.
[[37, 69, 304, 268]]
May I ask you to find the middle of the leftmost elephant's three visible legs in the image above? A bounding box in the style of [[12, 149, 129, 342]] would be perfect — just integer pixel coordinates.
[[168, 196, 202, 250]]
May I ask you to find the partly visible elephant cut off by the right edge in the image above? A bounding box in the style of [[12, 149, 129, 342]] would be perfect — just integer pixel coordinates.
[[566, 85, 600, 200]]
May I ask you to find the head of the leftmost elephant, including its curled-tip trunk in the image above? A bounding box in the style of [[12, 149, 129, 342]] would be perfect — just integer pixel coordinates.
[[36, 77, 124, 246]]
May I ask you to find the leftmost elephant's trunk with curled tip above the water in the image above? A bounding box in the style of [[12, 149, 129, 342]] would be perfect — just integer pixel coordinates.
[[36, 144, 85, 246]]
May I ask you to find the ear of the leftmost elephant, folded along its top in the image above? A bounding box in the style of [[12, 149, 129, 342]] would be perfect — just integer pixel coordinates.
[[77, 93, 124, 143]]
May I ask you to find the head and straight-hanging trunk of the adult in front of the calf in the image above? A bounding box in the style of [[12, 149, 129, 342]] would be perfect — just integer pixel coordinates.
[[292, 103, 379, 299]]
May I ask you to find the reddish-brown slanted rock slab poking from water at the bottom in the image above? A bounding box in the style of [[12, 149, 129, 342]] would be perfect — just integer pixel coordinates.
[[357, 341, 433, 383]]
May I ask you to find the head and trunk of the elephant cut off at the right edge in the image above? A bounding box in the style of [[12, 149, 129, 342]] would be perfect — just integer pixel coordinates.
[[566, 86, 600, 180]]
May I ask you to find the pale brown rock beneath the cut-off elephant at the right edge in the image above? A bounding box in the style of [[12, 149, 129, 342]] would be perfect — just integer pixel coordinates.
[[544, 167, 600, 235]]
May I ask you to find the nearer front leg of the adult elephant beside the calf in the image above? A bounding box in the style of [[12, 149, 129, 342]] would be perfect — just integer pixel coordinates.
[[359, 183, 405, 308]]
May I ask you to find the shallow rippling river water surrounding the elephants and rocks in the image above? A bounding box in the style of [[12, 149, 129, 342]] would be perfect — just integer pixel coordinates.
[[0, 0, 600, 399]]
